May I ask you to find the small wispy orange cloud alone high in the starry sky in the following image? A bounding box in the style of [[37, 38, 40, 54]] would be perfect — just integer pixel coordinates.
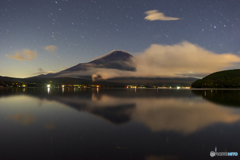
[[144, 10, 180, 21]]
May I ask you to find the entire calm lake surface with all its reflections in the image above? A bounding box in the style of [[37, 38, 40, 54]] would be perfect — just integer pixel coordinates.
[[0, 88, 240, 160]]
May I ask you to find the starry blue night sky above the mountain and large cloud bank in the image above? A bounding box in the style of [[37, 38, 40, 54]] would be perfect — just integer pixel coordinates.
[[0, 0, 240, 77]]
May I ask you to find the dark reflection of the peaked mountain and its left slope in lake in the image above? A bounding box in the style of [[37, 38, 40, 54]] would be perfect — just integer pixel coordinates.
[[0, 89, 136, 124]]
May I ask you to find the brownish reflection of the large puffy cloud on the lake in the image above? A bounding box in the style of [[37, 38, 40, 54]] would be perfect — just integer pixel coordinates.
[[132, 98, 240, 134]]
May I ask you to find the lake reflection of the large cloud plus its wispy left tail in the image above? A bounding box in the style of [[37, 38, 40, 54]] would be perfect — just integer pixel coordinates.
[[87, 94, 240, 134]]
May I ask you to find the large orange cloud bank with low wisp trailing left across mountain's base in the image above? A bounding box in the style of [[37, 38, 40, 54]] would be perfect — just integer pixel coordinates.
[[54, 41, 240, 80]]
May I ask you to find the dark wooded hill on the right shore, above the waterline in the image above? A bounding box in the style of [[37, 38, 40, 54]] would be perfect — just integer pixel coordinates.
[[192, 69, 240, 88]]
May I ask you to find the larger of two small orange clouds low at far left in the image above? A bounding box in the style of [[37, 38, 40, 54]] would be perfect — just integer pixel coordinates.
[[7, 49, 38, 61]]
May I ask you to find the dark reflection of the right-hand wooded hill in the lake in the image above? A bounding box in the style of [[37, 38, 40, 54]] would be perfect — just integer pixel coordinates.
[[192, 90, 240, 107]]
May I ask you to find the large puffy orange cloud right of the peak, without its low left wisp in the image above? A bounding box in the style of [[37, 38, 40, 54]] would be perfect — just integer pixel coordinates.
[[135, 42, 240, 77]]
